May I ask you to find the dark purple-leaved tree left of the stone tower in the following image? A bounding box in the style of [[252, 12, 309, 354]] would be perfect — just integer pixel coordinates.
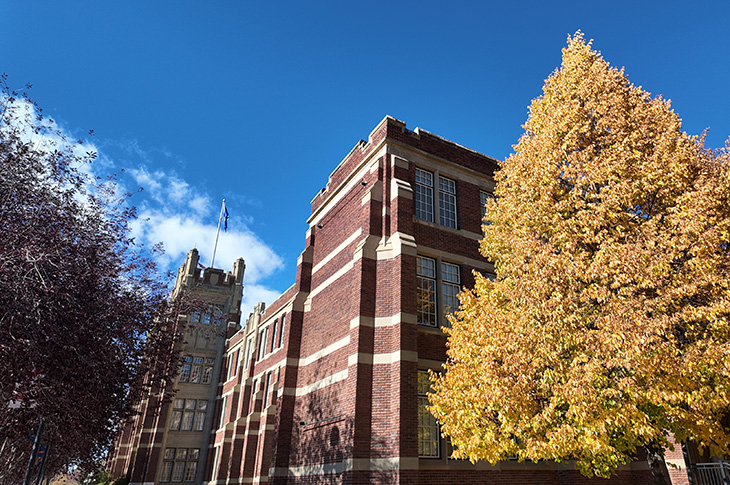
[[0, 76, 188, 482]]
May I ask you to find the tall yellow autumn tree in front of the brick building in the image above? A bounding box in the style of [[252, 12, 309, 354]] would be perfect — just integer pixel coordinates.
[[431, 32, 730, 483]]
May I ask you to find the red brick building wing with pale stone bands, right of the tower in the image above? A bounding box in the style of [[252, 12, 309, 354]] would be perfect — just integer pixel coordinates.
[[206, 117, 650, 485]]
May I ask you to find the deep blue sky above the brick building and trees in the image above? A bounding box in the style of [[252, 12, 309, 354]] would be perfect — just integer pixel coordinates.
[[0, 0, 730, 316]]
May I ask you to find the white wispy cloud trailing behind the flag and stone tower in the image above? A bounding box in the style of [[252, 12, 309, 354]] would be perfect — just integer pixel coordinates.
[[0, 98, 283, 319]]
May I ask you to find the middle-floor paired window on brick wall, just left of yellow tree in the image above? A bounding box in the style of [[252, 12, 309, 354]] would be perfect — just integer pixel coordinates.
[[416, 256, 461, 327]]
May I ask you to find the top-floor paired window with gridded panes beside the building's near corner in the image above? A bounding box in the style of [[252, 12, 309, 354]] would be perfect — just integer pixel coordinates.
[[415, 168, 457, 229]]
